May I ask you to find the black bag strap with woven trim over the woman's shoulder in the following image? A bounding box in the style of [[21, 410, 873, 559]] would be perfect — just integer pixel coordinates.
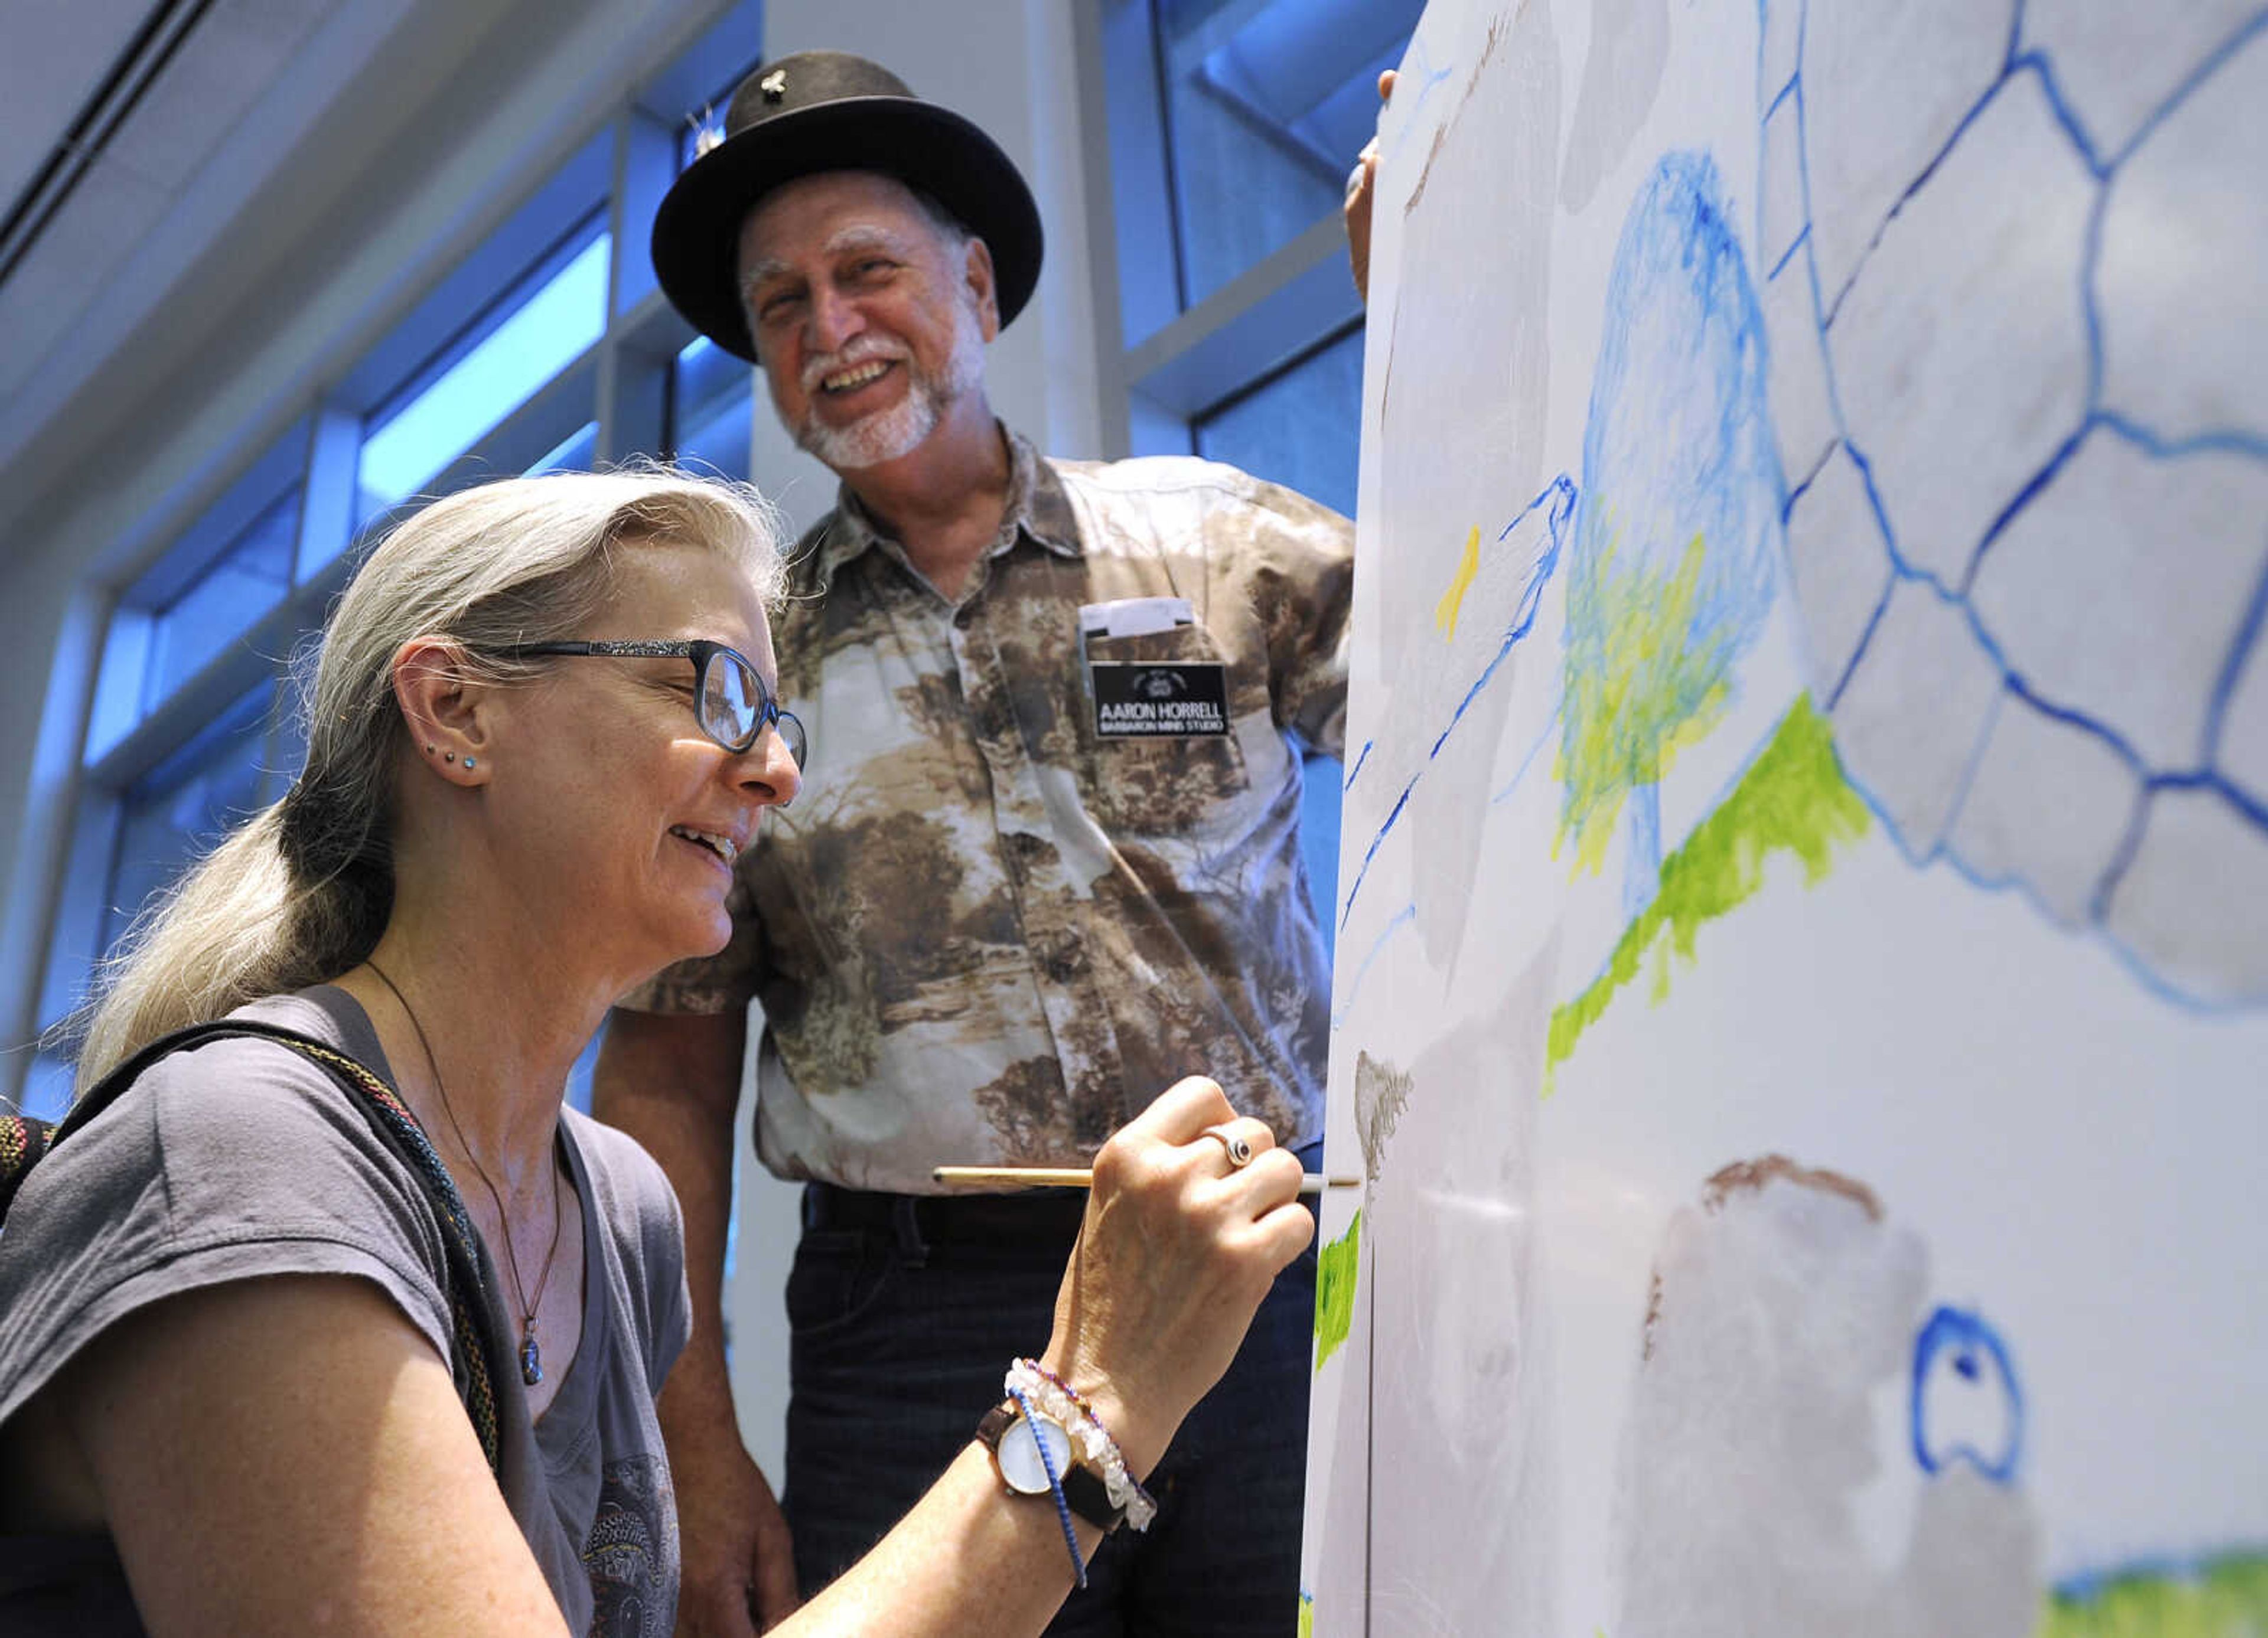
[[0, 1019, 506, 1479]]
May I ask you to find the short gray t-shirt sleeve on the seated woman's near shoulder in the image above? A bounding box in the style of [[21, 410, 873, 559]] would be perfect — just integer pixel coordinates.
[[0, 1039, 451, 1420]]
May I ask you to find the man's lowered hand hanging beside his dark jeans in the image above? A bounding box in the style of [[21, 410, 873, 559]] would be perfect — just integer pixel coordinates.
[[662, 1391, 801, 1638]]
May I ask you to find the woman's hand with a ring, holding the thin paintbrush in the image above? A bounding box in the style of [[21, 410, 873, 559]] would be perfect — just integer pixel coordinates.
[[1045, 1080, 1315, 1474]]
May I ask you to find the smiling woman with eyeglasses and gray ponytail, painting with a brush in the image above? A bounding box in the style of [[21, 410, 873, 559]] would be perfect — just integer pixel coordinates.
[[0, 472, 1311, 1638]]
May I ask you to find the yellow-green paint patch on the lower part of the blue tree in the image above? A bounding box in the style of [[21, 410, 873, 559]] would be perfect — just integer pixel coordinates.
[[1552, 531, 1731, 876]]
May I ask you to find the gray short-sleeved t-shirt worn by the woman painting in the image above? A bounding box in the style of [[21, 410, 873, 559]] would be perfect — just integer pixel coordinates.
[[0, 987, 692, 1638]]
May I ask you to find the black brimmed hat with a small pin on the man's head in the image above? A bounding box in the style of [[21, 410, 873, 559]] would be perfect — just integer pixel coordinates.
[[653, 52, 1041, 363]]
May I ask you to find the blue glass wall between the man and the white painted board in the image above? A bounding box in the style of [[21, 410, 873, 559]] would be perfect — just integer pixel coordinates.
[[1091, 0, 1425, 952]]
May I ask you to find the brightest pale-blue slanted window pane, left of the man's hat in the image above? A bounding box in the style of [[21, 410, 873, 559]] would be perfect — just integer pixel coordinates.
[[356, 234, 612, 520]]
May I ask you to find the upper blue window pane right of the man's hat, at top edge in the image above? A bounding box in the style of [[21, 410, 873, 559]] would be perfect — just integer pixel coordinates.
[[1156, 0, 1425, 306]]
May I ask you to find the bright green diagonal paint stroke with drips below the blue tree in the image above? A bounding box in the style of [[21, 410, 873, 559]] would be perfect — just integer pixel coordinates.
[[1544, 694, 1869, 1096]]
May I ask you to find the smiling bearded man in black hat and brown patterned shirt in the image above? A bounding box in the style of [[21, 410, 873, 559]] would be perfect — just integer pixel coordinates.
[[594, 52, 1352, 1633]]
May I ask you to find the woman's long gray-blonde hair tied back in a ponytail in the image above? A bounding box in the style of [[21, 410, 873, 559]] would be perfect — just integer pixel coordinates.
[[77, 467, 783, 1091]]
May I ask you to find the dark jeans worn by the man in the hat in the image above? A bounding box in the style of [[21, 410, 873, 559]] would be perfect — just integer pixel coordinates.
[[783, 1185, 1315, 1638]]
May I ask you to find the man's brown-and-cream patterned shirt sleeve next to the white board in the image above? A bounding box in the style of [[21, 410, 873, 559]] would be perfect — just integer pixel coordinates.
[[1225, 479, 1354, 755]]
